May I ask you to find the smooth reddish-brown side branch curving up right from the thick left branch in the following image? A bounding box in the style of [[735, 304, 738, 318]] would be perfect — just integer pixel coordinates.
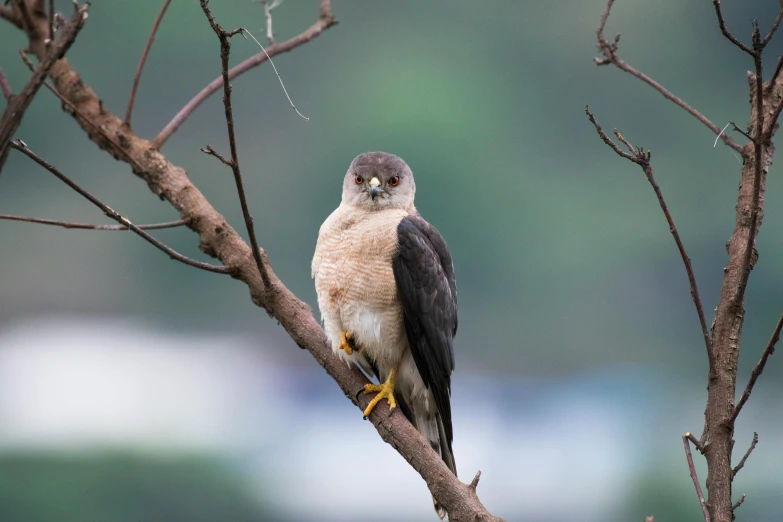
[[152, 10, 337, 149]]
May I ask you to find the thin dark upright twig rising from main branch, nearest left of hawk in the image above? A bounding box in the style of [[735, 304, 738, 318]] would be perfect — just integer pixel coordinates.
[[201, 0, 271, 288]]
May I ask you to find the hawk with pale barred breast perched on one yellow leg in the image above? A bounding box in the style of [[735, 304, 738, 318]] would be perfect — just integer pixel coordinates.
[[312, 152, 457, 519]]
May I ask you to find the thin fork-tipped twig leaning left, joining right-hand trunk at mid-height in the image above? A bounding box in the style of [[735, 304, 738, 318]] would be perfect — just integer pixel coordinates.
[[585, 106, 715, 373]]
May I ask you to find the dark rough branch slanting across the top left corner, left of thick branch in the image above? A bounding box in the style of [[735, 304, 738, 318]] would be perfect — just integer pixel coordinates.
[[0, 1, 89, 171]]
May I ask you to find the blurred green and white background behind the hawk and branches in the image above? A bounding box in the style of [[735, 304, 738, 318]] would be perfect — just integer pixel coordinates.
[[0, 0, 783, 521]]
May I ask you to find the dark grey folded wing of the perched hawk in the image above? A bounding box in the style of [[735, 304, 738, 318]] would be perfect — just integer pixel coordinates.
[[392, 215, 457, 444]]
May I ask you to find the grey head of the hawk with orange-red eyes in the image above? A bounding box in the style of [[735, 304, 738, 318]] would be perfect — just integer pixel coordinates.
[[343, 152, 416, 210]]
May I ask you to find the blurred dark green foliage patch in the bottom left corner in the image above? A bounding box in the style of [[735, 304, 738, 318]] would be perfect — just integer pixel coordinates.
[[0, 453, 272, 522]]
